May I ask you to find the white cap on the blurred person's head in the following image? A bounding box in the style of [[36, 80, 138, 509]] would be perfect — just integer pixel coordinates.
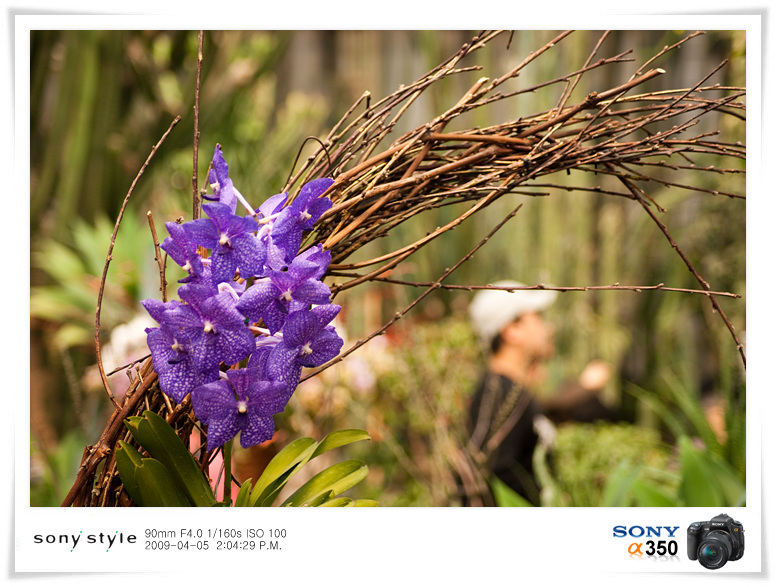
[[469, 281, 558, 344]]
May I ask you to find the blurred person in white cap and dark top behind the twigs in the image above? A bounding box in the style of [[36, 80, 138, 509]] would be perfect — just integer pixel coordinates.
[[467, 281, 616, 505]]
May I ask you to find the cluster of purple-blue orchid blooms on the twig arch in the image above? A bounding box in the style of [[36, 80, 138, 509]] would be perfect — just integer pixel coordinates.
[[142, 145, 343, 449]]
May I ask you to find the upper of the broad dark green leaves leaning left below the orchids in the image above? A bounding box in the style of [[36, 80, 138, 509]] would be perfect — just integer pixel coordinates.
[[126, 410, 216, 507]]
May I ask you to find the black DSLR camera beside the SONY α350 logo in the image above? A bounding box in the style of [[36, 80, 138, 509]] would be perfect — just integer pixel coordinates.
[[687, 514, 744, 569]]
